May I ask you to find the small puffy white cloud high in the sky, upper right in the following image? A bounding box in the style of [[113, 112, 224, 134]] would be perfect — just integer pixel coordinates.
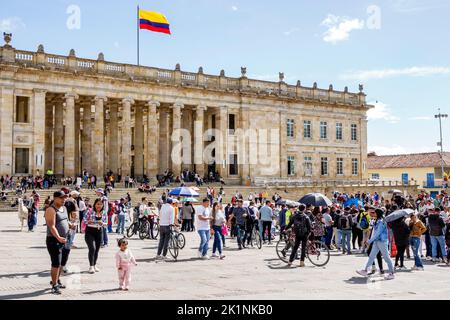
[[321, 14, 364, 44]]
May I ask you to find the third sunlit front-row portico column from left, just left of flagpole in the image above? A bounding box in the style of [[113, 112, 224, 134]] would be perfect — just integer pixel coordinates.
[[120, 98, 134, 177]]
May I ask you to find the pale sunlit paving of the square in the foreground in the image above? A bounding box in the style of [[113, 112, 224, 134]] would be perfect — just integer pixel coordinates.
[[0, 211, 450, 300]]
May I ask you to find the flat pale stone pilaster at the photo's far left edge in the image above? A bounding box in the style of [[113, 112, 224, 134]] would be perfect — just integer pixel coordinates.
[[0, 87, 15, 176]]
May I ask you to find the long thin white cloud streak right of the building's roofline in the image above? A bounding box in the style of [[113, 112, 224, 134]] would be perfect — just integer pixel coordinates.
[[340, 67, 450, 80]]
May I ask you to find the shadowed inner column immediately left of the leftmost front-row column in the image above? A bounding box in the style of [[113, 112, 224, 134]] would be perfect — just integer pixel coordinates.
[[53, 98, 64, 177]]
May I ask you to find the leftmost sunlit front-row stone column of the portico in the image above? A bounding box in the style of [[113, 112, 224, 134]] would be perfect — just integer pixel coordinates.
[[64, 93, 78, 177]]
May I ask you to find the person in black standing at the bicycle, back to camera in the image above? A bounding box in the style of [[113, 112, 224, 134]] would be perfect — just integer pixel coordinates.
[[286, 205, 311, 267]]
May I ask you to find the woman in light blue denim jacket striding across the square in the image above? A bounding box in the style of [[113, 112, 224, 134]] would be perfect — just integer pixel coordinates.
[[357, 207, 395, 280]]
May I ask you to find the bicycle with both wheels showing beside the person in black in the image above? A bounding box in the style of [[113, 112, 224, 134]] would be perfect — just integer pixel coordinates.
[[275, 231, 330, 267]]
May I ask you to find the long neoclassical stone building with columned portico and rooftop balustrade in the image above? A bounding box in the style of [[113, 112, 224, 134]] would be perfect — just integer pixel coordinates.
[[0, 35, 371, 183]]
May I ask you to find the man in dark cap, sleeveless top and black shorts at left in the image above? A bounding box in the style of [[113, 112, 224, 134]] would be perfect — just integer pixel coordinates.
[[45, 191, 74, 294]]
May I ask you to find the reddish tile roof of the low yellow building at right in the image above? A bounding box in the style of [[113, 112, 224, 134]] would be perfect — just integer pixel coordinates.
[[367, 152, 450, 169]]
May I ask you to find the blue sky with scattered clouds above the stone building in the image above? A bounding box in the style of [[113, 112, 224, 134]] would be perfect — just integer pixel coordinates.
[[0, 0, 450, 154]]
